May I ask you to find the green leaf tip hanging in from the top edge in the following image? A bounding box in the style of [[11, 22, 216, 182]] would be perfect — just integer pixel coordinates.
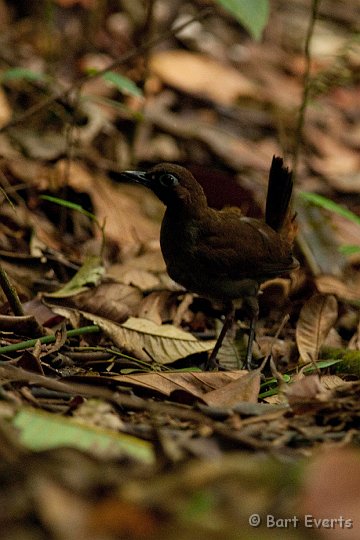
[[217, 0, 269, 40]]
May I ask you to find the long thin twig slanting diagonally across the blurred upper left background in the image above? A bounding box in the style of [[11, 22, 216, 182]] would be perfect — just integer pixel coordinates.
[[0, 8, 213, 133]]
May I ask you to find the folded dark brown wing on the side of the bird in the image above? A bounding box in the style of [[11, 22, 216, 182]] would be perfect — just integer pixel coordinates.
[[196, 209, 296, 280]]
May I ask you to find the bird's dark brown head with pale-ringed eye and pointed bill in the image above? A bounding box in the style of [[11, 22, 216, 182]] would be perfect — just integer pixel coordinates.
[[121, 163, 207, 207]]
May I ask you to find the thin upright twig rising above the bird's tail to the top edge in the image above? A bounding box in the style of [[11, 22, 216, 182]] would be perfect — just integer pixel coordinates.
[[292, 0, 320, 180]]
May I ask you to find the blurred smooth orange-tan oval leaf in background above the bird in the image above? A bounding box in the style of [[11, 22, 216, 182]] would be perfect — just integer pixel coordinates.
[[150, 50, 259, 105]]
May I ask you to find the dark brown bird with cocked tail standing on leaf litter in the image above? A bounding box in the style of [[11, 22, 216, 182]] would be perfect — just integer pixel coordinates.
[[121, 156, 299, 371]]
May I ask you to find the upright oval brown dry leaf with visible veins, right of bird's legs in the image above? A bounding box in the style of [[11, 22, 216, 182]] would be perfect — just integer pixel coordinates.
[[296, 294, 338, 363]]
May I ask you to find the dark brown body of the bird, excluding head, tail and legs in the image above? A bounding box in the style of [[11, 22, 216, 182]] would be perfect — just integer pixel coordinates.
[[161, 208, 297, 299]]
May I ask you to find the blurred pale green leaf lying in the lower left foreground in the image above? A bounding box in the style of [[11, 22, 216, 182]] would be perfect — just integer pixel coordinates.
[[13, 408, 154, 463]]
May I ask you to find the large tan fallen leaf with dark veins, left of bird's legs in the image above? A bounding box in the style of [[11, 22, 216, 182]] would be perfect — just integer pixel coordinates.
[[84, 313, 215, 364]]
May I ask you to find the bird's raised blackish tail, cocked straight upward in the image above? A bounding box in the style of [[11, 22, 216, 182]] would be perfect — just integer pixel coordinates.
[[265, 156, 297, 244]]
